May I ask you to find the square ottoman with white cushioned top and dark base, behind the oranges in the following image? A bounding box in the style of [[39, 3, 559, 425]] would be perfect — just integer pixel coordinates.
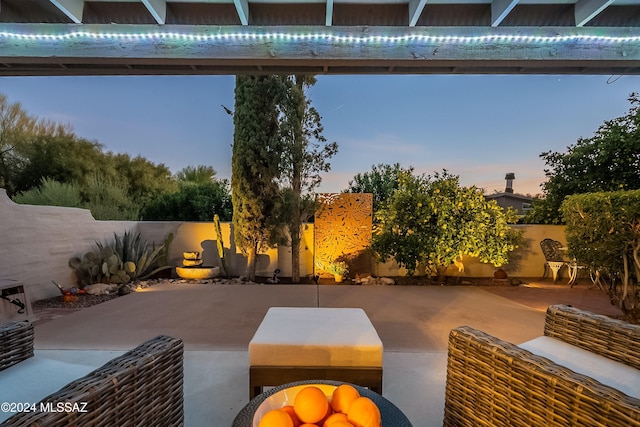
[[249, 307, 382, 398]]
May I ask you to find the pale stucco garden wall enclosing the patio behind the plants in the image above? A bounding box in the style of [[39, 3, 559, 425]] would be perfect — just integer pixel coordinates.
[[0, 189, 565, 301]]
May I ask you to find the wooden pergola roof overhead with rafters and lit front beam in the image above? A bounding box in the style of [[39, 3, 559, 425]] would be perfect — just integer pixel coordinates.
[[0, 0, 640, 76]]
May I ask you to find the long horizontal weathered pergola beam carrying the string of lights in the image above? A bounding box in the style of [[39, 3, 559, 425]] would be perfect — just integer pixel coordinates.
[[0, 24, 640, 75]]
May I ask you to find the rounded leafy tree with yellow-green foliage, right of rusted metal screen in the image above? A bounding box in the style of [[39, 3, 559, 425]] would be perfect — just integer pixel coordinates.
[[372, 171, 520, 278]]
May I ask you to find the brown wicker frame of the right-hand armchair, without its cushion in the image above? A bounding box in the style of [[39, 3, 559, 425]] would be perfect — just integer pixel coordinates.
[[444, 305, 640, 427]]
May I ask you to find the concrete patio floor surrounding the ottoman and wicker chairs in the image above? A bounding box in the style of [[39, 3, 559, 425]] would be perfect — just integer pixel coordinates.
[[18, 282, 620, 427]]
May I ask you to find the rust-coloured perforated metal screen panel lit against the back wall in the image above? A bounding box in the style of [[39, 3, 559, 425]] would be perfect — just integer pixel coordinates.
[[314, 193, 373, 275]]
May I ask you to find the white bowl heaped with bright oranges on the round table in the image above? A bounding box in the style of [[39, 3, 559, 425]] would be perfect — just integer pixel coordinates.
[[253, 384, 382, 427]]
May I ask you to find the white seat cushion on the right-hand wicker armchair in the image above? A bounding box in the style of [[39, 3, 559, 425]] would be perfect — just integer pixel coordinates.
[[519, 336, 640, 398]]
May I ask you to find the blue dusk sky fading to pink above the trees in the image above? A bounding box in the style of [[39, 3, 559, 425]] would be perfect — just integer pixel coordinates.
[[0, 75, 640, 194]]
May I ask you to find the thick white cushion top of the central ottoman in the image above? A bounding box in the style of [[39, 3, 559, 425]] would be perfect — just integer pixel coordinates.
[[249, 307, 383, 367]]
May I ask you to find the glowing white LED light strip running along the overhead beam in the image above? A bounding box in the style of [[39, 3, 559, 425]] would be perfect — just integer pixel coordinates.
[[0, 31, 640, 44]]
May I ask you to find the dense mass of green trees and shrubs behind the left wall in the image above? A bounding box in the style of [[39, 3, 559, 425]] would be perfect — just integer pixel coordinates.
[[0, 94, 231, 221]]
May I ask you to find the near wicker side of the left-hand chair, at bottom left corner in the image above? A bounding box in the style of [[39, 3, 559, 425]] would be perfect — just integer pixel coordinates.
[[0, 336, 184, 427]]
